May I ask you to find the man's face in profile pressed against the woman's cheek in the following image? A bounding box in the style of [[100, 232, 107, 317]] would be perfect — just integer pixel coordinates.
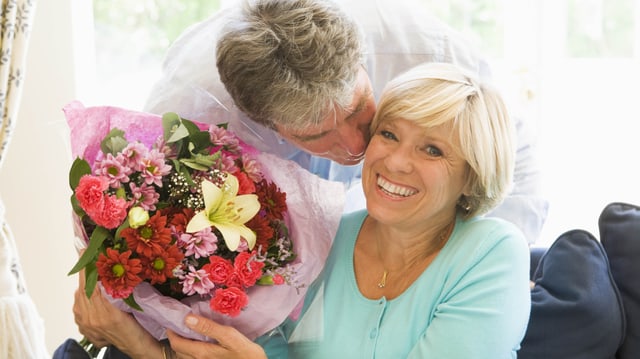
[[277, 68, 376, 165]]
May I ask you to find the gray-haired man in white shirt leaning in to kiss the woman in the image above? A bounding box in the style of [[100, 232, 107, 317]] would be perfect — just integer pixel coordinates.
[[145, 0, 547, 243]]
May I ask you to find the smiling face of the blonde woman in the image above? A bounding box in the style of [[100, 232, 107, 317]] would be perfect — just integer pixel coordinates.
[[362, 119, 468, 228]]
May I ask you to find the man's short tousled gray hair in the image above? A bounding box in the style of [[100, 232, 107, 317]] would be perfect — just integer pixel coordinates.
[[217, 0, 364, 130]]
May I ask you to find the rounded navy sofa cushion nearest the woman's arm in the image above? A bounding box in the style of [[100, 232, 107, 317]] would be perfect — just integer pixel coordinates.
[[518, 230, 625, 359]]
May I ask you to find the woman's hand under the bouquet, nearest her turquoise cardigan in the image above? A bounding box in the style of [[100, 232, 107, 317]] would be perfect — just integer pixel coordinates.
[[167, 314, 267, 359]]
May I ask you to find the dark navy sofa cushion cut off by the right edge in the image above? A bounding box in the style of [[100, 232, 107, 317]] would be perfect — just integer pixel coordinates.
[[598, 202, 640, 359]]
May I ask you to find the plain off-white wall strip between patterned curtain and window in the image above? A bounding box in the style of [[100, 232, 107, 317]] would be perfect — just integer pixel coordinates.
[[0, 0, 81, 353]]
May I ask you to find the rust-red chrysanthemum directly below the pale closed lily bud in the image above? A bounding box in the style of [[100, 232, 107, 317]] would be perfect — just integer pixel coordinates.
[[121, 213, 171, 258]]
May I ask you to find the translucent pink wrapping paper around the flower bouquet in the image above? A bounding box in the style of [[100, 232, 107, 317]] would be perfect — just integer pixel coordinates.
[[64, 102, 345, 340]]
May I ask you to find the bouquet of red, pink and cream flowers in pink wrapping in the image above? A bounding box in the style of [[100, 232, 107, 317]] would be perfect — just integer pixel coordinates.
[[64, 102, 344, 340]]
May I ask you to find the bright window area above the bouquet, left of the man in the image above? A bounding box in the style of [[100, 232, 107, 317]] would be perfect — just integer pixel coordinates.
[[88, 0, 220, 109]]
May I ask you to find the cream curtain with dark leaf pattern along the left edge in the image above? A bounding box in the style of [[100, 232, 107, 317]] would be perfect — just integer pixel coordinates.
[[0, 0, 50, 359]]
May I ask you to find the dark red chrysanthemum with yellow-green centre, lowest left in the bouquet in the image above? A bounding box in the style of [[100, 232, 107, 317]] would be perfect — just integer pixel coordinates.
[[96, 248, 142, 298]]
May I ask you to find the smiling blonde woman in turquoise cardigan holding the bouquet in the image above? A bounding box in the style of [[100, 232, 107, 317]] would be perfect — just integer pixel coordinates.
[[169, 63, 530, 359]]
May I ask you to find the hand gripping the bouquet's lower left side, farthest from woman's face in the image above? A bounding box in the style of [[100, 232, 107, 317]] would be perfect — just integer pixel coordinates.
[[73, 270, 162, 359]]
